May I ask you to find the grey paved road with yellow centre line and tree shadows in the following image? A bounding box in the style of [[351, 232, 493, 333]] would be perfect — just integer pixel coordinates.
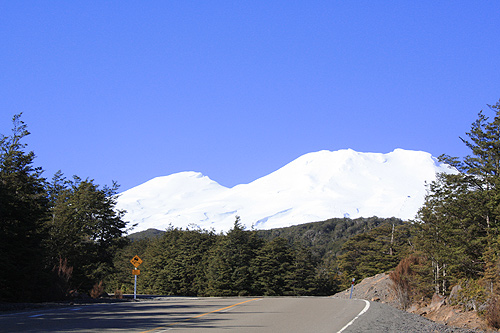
[[0, 297, 366, 333]]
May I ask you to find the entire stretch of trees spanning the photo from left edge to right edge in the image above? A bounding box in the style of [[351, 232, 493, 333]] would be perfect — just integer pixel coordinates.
[[0, 98, 500, 326]]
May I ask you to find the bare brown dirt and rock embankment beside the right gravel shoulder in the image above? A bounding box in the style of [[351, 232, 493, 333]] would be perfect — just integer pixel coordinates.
[[335, 273, 487, 331]]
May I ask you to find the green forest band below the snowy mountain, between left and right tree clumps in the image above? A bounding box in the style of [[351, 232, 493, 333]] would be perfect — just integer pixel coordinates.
[[108, 217, 408, 296]]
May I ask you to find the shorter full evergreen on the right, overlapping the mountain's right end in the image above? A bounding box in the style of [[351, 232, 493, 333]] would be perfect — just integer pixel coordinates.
[[415, 174, 488, 294]]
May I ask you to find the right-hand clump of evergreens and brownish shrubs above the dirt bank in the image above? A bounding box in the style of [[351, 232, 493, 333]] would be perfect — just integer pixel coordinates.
[[394, 102, 500, 316]]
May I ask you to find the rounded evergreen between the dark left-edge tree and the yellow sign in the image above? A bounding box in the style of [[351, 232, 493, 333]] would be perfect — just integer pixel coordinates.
[[48, 173, 126, 291]]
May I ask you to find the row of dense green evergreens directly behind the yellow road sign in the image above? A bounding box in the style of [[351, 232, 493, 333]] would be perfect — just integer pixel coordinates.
[[111, 217, 335, 296]]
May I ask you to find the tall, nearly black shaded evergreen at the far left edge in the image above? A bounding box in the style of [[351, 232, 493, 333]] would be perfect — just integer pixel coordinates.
[[0, 114, 48, 301]]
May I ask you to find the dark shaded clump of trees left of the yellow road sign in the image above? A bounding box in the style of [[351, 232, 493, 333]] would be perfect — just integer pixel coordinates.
[[0, 114, 126, 301]]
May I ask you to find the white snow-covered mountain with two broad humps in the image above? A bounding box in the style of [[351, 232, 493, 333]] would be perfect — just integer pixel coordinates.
[[117, 149, 457, 232]]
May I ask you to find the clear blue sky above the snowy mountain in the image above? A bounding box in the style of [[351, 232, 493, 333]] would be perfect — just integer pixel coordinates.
[[0, 0, 500, 190]]
